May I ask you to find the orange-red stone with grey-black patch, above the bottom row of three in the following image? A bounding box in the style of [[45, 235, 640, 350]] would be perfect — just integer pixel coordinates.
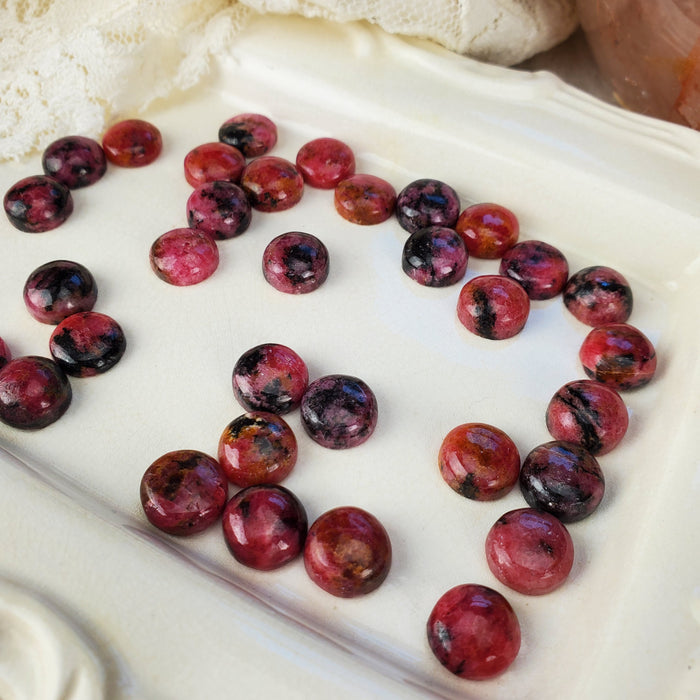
[[218, 411, 297, 488]]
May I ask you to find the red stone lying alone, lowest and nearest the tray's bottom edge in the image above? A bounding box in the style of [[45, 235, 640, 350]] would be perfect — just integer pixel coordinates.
[[427, 583, 520, 681]]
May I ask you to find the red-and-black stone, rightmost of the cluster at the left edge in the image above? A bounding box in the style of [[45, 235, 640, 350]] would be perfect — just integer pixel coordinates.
[[49, 311, 126, 377]]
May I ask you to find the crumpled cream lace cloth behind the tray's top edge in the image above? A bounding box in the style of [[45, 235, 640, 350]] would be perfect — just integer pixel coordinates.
[[0, 0, 577, 161]]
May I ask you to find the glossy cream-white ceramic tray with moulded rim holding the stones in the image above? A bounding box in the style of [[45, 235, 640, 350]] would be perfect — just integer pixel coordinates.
[[0, 17, 700, 700]]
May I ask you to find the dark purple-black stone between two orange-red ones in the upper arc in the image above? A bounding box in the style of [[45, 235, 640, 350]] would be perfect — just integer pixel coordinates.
[[396, 178, 461, 233]]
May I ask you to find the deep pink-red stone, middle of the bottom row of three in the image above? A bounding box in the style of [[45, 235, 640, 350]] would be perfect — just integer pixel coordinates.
[[222, 484, 308, 571]]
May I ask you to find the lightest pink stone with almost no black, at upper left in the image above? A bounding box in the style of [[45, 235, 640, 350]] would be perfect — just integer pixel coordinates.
[[150, 228, 219, 287]]
